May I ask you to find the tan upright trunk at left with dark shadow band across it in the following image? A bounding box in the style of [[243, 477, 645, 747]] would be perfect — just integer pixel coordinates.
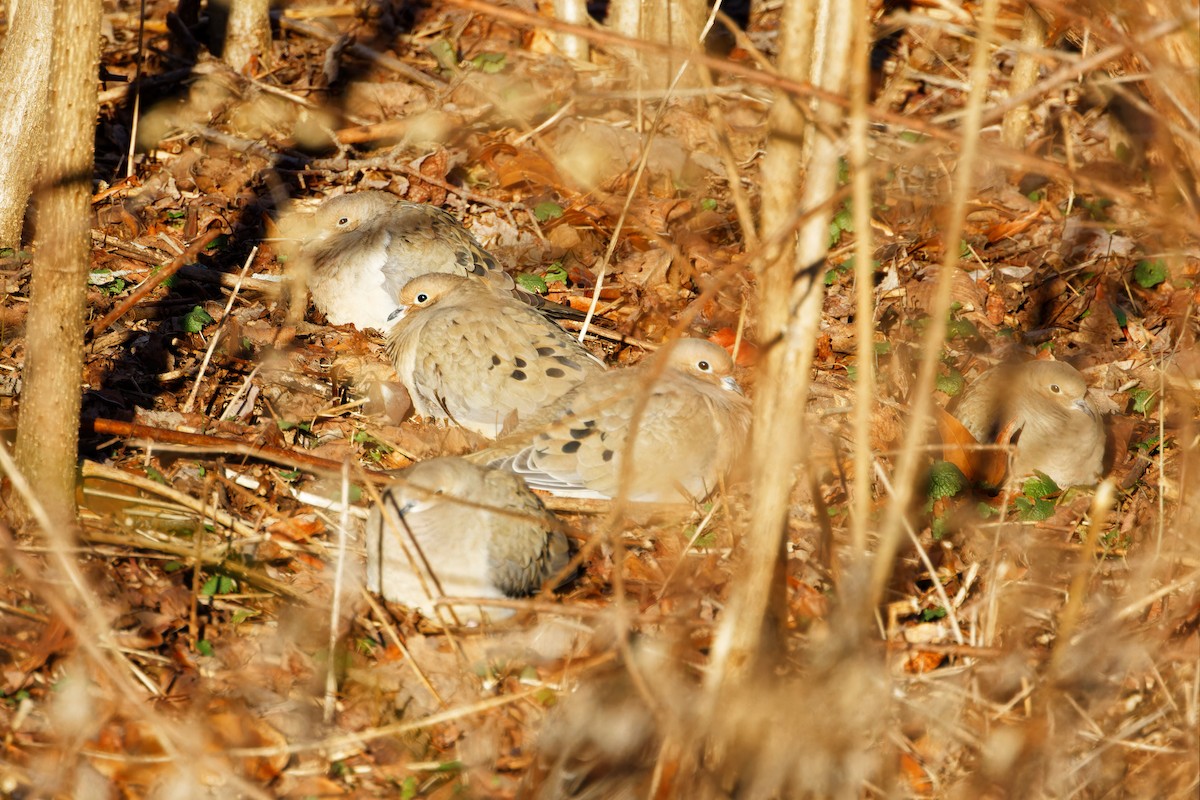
[[17, 0, 101, 533]]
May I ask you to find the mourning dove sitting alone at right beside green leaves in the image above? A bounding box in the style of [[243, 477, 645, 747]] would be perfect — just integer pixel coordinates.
[[954, 361, 1105, 488]]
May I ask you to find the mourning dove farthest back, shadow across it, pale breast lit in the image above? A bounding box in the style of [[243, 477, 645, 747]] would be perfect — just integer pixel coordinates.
[[300, 191, 583, 331]]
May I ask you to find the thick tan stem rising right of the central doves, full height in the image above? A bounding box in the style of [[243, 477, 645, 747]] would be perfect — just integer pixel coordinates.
[[708, 0, 852, 690]]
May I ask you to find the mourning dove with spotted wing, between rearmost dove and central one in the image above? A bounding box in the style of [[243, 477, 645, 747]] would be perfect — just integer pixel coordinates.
[[386, 275, 604, 439]]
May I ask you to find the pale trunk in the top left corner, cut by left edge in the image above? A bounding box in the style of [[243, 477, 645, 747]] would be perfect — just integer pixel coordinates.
[[0, 0, 54, 248]]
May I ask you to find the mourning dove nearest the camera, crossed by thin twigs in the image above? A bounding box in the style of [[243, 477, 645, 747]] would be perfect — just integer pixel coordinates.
[[366, 458, 569, 622]]
